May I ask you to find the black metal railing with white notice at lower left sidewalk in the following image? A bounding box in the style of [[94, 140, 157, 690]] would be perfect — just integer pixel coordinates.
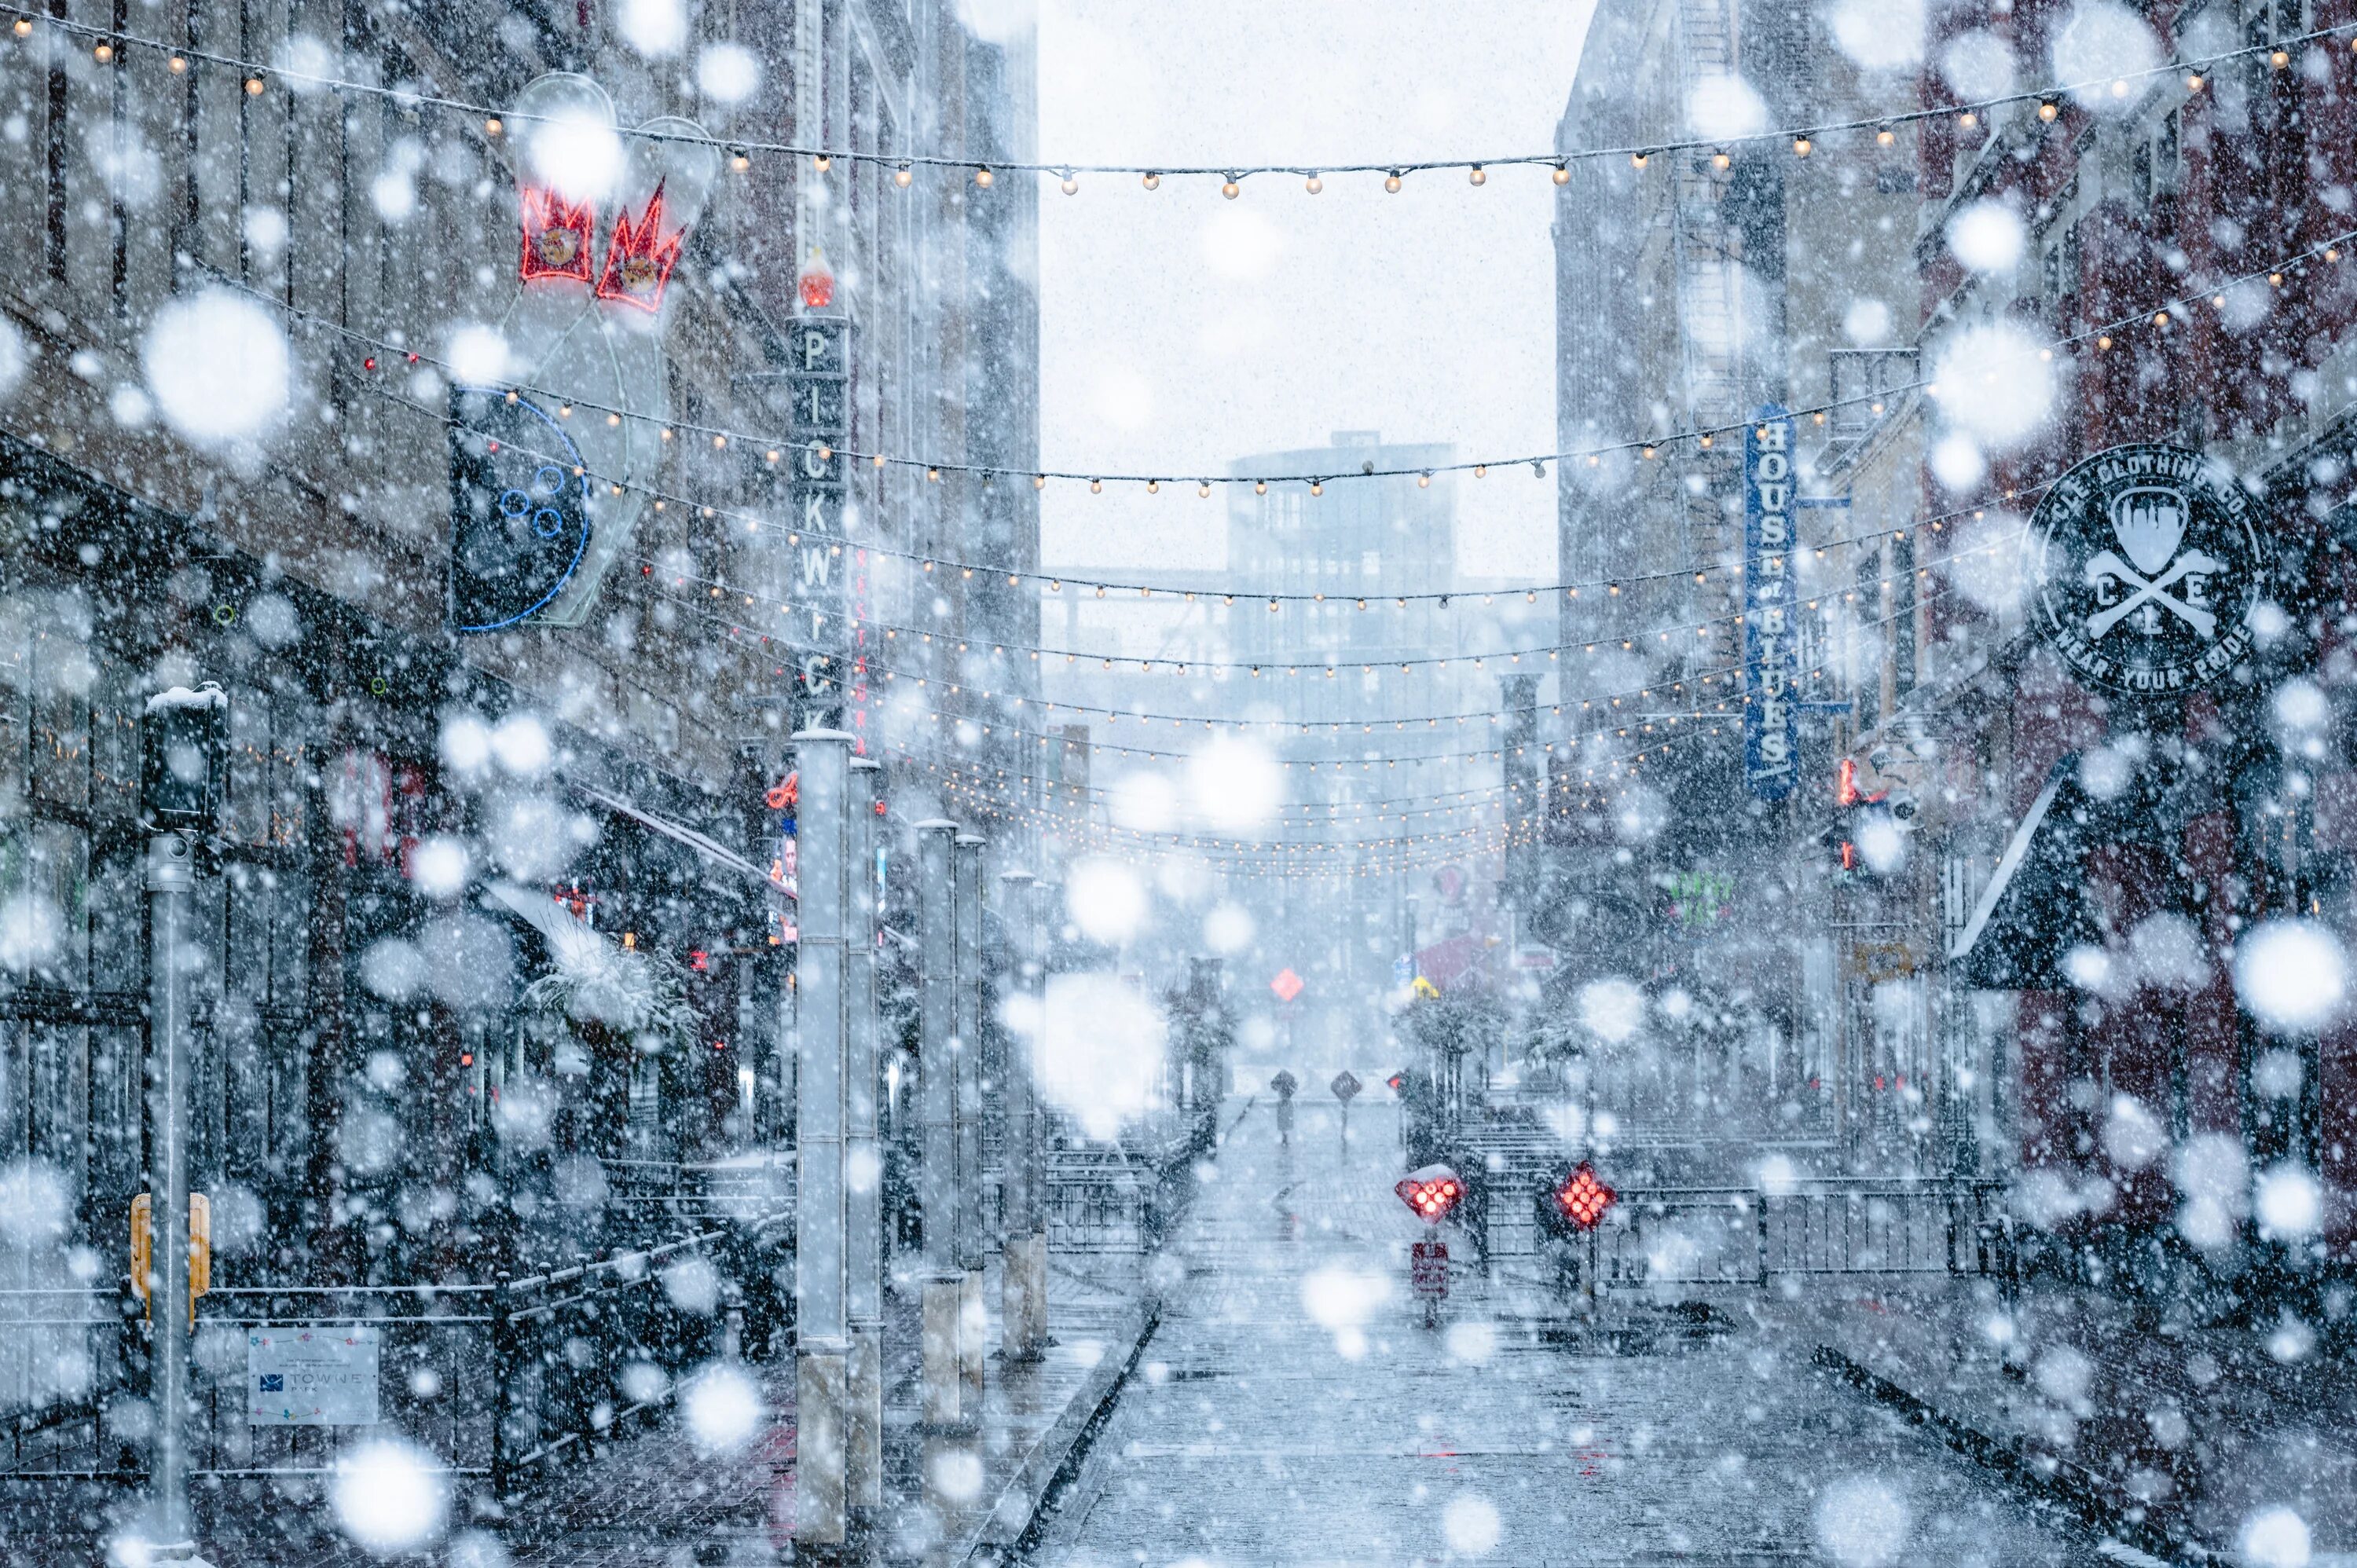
[[5, 1210, 792, 1495]]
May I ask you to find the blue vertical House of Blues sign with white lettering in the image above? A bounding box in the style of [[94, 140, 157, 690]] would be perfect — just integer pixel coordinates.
[[1744, 403, 1801, 800]]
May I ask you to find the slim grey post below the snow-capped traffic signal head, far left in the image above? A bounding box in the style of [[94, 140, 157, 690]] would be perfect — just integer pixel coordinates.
[[146, 833, 196, 1559]]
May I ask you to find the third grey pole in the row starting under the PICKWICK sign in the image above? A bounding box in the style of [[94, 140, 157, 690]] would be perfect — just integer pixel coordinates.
[[917, 819, 962, 1427]]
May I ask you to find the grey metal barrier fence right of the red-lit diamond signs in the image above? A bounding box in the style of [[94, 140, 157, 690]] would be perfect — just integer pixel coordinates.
[[1490, 1181, 2013, 1288]]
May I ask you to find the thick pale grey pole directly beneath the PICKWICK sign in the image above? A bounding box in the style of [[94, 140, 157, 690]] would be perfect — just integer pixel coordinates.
[[794, 728, 851, 1547]]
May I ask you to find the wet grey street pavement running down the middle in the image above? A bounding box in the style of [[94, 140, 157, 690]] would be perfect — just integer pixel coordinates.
[[1030, 1104, 2138, 1568]]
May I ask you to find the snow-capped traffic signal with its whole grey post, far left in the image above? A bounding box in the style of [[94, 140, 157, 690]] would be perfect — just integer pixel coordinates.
[[139, 681, 229, 1563]]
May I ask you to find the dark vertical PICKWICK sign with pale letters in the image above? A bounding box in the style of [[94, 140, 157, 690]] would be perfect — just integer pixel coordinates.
[[785, 316, 851, 728]]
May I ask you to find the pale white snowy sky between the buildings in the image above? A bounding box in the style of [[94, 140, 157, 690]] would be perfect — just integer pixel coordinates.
[[1039, 0, 1593, 580]]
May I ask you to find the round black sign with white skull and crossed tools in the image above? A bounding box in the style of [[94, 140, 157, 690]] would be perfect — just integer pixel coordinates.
[[2029, 445, 2275, 695]]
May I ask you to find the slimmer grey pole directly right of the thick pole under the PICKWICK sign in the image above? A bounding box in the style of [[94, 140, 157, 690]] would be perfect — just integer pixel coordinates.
[[844, 757, 884, 1523]]
